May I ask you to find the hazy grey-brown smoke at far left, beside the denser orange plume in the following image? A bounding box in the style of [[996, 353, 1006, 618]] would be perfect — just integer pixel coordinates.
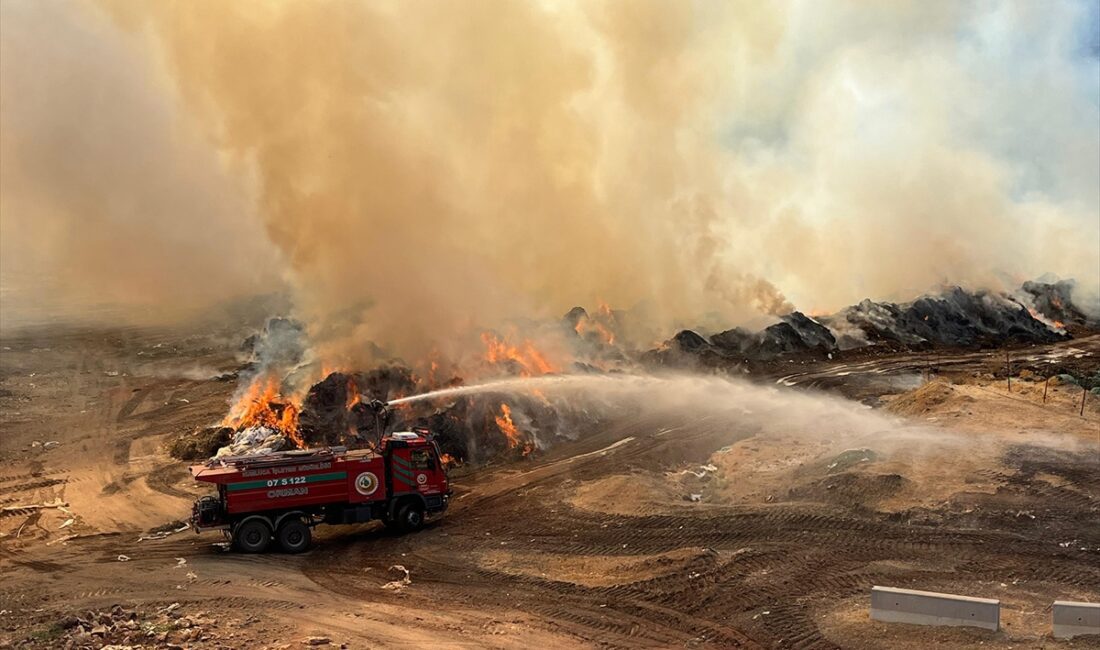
[[0, 0, 278, 326]]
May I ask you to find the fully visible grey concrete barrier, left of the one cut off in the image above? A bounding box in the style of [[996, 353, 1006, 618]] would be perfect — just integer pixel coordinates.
[[871, 586, 1001, 631]]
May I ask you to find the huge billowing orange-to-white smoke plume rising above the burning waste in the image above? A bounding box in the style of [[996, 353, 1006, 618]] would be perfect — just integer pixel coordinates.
[[4, 0, 1100, 364]]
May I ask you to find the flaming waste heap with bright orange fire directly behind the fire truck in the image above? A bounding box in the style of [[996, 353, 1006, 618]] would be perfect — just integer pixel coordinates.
[[171, 319, 620, 462]]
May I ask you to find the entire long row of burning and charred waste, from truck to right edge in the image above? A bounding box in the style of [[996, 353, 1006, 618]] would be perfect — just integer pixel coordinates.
[[171, 277, 1100, 463]]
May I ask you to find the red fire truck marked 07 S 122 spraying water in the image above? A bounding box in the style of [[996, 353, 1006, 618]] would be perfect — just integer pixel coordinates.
[[191, 430, 451, 553]]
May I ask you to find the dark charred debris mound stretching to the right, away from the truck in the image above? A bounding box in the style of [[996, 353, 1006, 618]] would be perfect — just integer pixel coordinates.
[[641, 280, 1086, 367]]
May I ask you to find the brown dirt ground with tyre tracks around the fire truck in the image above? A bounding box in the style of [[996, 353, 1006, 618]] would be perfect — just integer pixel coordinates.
[[0, 329, 1100, 648]]
